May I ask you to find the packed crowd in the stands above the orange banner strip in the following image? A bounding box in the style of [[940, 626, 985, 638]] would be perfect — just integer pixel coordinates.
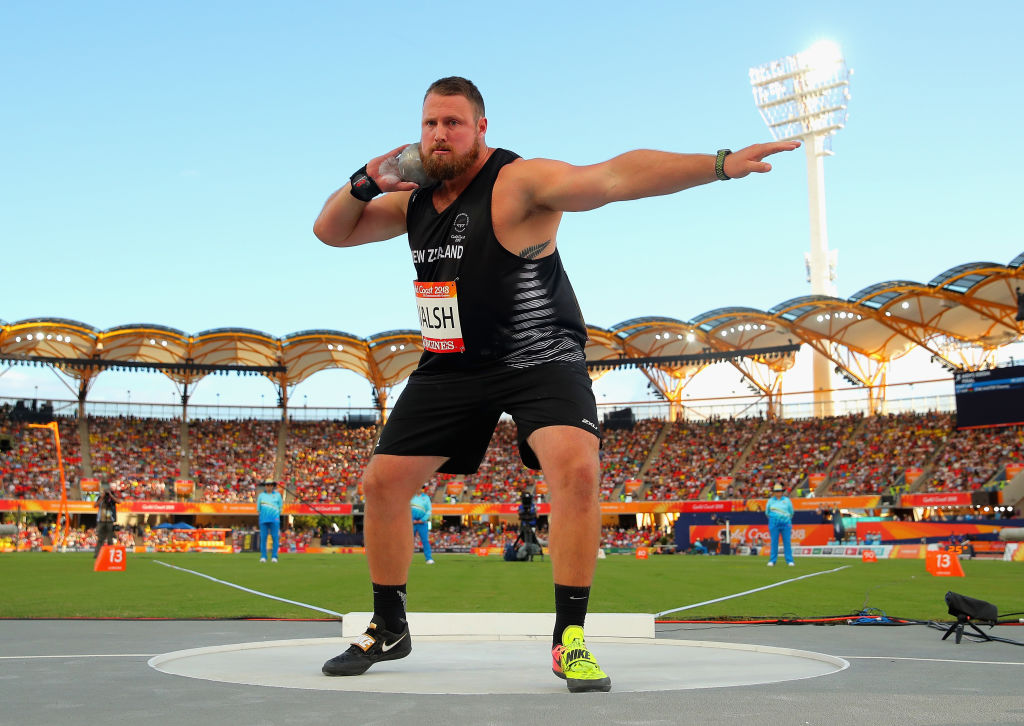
[[0, 413, 1024, 506]]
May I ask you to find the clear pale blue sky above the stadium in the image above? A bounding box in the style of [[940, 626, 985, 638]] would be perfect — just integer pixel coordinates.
[[0, 0, 1024, 403]]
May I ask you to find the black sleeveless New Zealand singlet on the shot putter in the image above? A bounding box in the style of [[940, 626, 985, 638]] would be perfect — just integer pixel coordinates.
[[407, 148, 587, 373]]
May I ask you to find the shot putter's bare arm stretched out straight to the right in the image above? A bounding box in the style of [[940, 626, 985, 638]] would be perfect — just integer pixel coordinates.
[[513, 141, 800, 212]]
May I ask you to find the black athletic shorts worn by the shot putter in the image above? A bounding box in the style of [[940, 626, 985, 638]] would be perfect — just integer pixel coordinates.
[[374, 364, 601, 474]]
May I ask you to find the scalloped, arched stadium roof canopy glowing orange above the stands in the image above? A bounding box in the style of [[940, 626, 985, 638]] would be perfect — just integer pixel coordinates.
[[0, 253, 1024, 397]]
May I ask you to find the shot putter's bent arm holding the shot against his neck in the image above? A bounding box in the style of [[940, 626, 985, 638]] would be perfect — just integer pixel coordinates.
[[313, 146, 416, 247]]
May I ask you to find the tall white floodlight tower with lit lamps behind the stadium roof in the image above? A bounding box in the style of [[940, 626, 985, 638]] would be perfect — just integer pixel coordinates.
[[751, 41, 851, 416]]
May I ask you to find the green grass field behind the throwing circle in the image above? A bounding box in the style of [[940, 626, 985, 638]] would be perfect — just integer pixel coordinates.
[[0, 553, 1024, 620]]
